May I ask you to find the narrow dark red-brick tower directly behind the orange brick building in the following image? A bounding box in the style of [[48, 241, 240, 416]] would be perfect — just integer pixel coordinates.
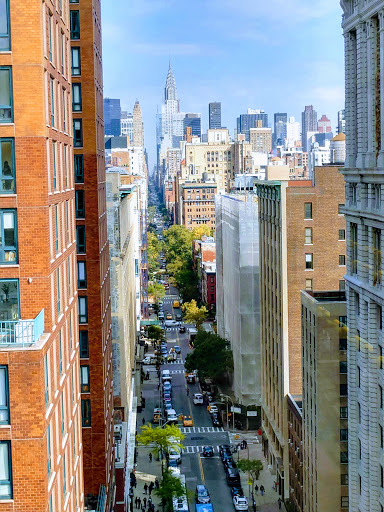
[[70, 0, 114, 506]]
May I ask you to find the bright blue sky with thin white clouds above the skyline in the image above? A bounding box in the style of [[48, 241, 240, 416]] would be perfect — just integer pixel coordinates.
[[102, 0, 344, 169]]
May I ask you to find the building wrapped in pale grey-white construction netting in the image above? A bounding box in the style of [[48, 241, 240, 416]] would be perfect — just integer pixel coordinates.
[[216, 195, 261, 410]]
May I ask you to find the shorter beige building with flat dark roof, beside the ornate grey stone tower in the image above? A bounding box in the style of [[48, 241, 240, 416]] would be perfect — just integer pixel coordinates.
[[299, 291, 348, 512]]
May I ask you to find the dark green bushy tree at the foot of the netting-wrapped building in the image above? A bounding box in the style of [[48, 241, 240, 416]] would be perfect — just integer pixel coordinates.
[[185, 329, 233, 381]]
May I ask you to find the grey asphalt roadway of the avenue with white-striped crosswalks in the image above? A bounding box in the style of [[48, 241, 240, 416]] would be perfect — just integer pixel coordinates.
[[144, 285, 234, 512]]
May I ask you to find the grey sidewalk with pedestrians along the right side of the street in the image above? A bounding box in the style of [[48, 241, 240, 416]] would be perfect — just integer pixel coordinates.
[[229, 432, 284, 512]]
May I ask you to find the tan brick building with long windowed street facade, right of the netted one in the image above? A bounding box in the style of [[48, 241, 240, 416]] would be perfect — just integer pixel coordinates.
[[257, 166, 346, 498]]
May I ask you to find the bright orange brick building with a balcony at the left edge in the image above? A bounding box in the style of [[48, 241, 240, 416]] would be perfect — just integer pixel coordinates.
[[0, 0, 84, 512]]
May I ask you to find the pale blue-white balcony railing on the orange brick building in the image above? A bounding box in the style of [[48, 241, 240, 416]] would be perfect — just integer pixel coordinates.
[[0, 309, 44, 348]]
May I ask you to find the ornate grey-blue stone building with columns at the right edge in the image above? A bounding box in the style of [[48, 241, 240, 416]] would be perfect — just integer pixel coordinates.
[[341, 0, 384, 512]]
